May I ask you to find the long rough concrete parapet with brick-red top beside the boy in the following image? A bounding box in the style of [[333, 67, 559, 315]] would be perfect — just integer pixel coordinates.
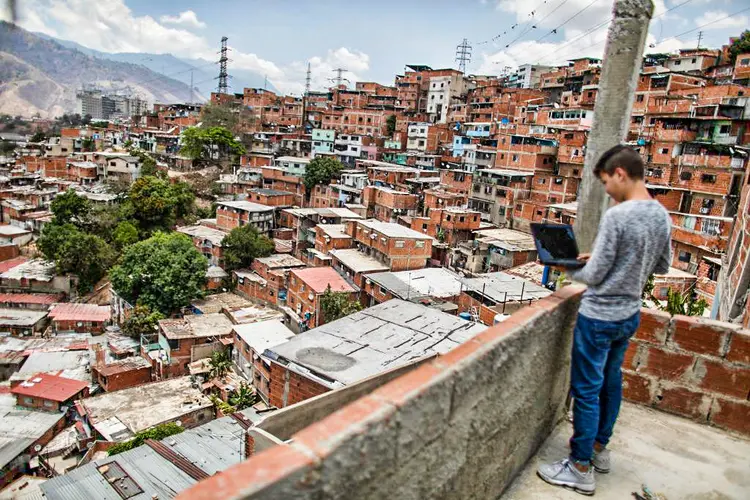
[[178, 286, 582, 499]]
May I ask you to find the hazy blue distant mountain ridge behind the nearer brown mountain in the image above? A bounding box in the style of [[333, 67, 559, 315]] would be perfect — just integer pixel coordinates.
[[34, 33, 278, 99]]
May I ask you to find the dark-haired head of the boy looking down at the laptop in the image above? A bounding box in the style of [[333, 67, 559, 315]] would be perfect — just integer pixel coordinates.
[[594, 145, 644, 202]]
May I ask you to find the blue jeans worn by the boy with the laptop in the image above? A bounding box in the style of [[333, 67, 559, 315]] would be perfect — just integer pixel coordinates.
[[570, 312, 641, 464]]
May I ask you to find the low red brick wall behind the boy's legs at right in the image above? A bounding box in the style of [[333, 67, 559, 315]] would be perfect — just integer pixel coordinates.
[[623, 309, 750, 435]]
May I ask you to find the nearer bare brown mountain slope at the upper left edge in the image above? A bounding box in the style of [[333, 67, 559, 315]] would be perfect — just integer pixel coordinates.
[[0, 21, 195, 117]]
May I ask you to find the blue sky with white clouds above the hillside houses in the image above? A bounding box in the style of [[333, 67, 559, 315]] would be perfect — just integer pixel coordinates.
[[2, 0, 750, 94]]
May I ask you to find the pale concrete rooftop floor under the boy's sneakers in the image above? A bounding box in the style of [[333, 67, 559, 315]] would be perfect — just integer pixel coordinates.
[[501, 403, 750, 500]]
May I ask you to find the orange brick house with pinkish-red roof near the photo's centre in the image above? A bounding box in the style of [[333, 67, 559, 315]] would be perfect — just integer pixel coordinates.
[[287, 267, 357, 328]]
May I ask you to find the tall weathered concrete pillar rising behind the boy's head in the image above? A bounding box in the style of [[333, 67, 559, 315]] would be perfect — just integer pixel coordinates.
[[575, 0, 654, 252]]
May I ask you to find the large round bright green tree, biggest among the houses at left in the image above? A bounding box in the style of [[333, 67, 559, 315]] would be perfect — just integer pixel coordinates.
[[110, 232, 208, 316]]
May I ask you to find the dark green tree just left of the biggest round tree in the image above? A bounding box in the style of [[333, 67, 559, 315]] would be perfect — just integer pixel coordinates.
[[37, 224, 116, 292]]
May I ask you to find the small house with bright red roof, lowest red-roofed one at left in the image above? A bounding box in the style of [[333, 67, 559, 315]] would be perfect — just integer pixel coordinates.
[[10, 373, 89, 412]]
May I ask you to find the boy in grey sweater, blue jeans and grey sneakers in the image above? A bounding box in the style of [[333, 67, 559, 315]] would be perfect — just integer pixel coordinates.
[[537, 146, 671, 495]]
